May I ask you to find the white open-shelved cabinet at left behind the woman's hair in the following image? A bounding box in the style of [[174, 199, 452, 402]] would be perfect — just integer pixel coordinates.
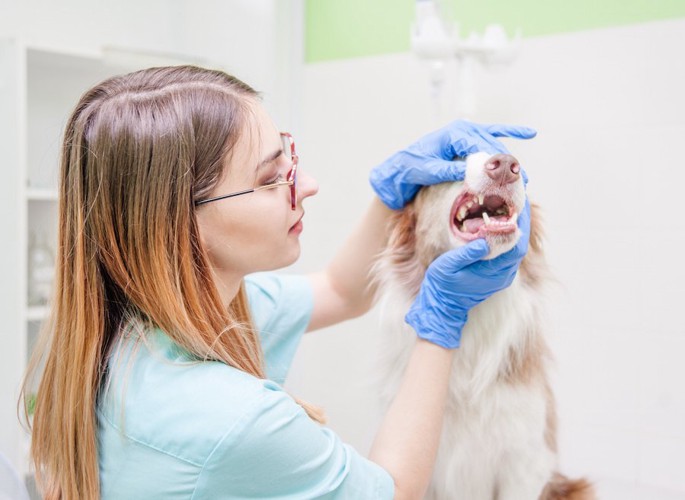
[[0, 39, 197, 484]]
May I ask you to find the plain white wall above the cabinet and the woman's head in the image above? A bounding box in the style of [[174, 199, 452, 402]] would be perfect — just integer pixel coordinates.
[[0, 0, 300, 120]]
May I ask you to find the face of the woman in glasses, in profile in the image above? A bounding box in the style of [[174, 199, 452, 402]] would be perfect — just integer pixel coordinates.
[[197, 103, 319, 286]]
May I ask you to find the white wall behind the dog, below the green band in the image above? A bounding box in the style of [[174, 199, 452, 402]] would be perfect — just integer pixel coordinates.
[[290, 20, 685, 499]]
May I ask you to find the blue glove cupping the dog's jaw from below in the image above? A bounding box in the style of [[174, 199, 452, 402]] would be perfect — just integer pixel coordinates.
[[405, 200, 530, 349]]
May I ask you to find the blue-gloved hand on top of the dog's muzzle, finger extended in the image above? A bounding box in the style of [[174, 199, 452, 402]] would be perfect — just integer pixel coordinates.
[[370, 120, 537, 210]]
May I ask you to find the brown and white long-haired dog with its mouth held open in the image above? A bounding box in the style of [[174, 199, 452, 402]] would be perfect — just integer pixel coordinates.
[[375, 153, 595, 500]]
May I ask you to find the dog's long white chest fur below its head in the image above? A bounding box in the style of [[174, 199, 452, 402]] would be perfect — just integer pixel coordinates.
[[381, 264, 556, 500]]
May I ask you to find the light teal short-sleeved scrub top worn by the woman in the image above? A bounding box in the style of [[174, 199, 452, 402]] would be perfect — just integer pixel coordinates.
[[97, 273, 394, 500]]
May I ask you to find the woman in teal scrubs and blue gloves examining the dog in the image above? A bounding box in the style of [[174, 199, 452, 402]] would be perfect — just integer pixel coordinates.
[[22, 67, 534, 499]]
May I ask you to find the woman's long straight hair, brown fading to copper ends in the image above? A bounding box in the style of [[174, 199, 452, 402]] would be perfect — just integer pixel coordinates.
[[24, 66, 318, 499]]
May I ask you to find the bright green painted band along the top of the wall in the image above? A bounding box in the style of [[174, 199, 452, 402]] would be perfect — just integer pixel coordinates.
[[305, 0, 685, 62]]
